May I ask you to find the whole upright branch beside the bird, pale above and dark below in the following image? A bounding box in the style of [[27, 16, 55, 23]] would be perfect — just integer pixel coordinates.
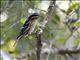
[[36, 0, 55, 60]]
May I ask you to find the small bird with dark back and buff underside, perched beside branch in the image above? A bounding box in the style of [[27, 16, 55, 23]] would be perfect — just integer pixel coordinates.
[[13, 13, 39, 46]]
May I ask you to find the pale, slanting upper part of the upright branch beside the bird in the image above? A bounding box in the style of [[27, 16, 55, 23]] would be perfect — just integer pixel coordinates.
[[39, 0, 56, 34]]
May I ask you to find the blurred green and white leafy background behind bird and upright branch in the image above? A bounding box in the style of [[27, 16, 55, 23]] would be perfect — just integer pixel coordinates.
[[0, 0, 80, 60]]
